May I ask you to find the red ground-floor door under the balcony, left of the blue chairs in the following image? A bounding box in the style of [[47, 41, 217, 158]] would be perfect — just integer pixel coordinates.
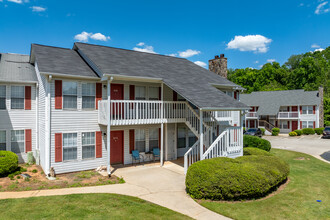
[[110, 131, 124, 164]]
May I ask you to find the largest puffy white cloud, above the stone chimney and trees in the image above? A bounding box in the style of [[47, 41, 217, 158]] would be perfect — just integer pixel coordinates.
[[227, 35, 272, 53]]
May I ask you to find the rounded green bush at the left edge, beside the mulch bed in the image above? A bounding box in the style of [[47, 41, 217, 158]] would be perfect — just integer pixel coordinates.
[[0, 151, 18, 176]]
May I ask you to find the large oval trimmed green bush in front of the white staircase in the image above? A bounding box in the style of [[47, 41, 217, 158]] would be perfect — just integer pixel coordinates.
[[186, 154, 290, 200]]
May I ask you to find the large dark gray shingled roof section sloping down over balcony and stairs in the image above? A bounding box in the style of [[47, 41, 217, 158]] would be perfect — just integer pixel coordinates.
[[74, 43, 247, 109]]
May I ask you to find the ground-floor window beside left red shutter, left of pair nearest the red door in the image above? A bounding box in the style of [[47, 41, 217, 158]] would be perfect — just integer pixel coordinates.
[[63, 133, 78, 161]]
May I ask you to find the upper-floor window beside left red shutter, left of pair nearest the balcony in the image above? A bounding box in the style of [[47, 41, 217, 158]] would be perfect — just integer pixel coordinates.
[[63, 82, 77, 109]]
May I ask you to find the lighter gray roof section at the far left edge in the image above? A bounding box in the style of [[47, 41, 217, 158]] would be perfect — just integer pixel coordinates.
[[0, 53, 38, 82]]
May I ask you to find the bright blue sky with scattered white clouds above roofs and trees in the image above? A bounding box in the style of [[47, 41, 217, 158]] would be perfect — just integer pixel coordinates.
[[0, 0, 330, 68]]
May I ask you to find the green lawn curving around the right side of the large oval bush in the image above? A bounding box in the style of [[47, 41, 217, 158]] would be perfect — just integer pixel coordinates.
[[201, 149, 330, 219]]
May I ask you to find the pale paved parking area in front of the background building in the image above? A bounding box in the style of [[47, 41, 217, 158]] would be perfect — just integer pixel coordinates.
[[263, 134, 330, 163]]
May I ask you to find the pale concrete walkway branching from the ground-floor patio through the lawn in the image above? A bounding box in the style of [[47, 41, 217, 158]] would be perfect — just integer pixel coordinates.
[[0, 162, 228, 220]]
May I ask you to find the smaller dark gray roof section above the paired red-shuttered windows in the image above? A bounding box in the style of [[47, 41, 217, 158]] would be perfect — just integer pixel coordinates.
[[31, 44, 98, 78]]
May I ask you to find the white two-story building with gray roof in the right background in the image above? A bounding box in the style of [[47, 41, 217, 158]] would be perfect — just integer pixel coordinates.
[[241, 87, 323, 133]]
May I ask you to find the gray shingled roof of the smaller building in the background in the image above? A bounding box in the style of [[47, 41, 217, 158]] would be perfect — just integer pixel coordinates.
[[240, 90, 321, 115]]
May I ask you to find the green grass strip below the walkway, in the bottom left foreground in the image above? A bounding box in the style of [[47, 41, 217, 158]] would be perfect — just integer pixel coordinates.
[[0, 194, 190, 220]]
